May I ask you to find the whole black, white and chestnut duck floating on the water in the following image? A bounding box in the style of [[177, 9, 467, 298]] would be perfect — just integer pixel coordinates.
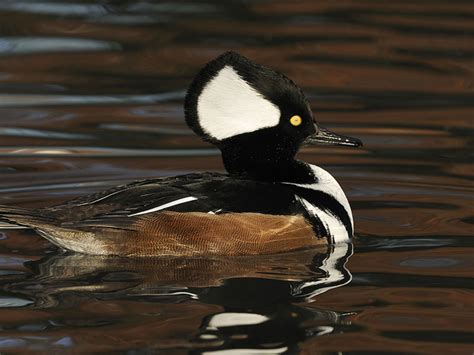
[[0, 51, 362, 257]]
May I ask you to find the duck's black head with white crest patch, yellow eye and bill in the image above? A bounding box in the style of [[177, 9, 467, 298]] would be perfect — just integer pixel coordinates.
[[185, 52, 361, 179]]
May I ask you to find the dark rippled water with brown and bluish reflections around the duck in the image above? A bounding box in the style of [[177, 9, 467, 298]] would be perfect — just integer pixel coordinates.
[[0, 0, 474, 354]]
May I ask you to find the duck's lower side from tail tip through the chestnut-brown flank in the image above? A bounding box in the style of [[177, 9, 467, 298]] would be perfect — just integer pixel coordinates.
[[0, 206, 327, 256]]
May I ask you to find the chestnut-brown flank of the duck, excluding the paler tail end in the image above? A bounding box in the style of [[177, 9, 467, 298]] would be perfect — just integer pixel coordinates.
[[111, 212, 325, 256]]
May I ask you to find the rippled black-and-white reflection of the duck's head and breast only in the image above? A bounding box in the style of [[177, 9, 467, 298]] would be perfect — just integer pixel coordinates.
[[190, 244, 352, 354]]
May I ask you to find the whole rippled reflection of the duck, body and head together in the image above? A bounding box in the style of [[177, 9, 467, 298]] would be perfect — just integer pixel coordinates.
[[3, 244, 352, 353]]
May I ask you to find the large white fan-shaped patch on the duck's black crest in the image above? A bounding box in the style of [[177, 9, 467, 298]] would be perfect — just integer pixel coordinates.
[[197, 66, 280, 140]]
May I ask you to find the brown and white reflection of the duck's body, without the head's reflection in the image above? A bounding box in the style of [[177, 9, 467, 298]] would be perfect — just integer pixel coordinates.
[[5, 244, 352, 309]]
